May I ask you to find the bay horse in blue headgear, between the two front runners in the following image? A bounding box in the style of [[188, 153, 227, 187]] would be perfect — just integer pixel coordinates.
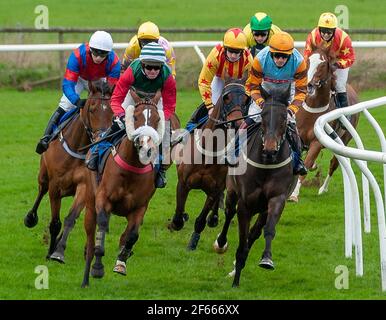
[[168, 73, 248, 250]]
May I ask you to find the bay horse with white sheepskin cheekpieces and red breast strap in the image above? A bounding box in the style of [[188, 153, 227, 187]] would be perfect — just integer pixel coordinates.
[[82, 91, 165, 287]]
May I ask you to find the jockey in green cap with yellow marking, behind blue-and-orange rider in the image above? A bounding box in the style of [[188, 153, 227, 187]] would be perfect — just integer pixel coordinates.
[[243, 12, 281, 57]]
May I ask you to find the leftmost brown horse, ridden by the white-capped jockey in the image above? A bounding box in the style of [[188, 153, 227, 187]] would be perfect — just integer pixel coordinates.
[[24, 81, 113, 263]]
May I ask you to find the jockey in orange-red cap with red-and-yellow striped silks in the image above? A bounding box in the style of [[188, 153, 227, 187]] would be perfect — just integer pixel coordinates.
[[182, 28, 252, 132]]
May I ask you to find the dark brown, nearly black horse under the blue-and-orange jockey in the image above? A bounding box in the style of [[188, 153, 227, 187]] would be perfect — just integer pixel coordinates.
[[216, 85, 296, 287]]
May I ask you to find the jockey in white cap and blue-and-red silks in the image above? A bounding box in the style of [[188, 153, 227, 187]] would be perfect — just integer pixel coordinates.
[[36, 31, 121, 154]]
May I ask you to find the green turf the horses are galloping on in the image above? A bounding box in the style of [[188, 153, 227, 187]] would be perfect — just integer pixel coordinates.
[[0, 90, 386, 300]]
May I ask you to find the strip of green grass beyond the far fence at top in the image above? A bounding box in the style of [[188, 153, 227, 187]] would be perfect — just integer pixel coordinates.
[[0, 0, 384, 28]]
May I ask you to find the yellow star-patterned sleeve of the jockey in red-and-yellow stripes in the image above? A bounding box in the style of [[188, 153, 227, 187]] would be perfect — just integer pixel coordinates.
[[198, 48, 218, 107]]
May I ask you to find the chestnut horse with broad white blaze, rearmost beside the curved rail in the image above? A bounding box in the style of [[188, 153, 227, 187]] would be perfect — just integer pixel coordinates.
[[289, 48, 359, 202]]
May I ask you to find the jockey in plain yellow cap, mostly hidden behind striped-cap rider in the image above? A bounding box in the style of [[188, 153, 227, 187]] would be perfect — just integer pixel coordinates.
[[122, 21, 176, 78]]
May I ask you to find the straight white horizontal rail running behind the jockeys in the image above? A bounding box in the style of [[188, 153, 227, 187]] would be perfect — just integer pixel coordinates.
[[0, 41, 386, 63]]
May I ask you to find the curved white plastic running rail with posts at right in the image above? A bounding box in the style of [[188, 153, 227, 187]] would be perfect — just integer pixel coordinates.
[[314, 96, 386, 291]]
